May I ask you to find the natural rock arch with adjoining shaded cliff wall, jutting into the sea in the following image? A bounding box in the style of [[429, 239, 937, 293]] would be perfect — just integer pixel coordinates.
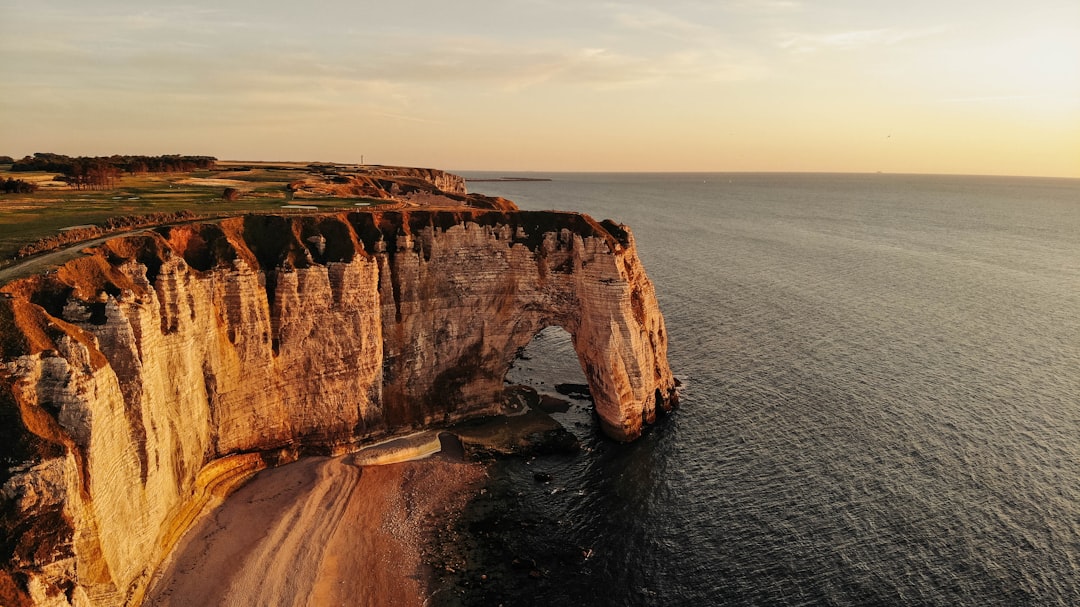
[[362, 212, 676, 441]]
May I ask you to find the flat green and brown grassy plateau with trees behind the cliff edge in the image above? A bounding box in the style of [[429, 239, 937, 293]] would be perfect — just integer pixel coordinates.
[[0, 154, 516, 268]]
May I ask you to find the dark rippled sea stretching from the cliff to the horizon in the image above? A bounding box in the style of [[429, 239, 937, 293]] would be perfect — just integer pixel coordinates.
[[456, 172, 1080, 607]]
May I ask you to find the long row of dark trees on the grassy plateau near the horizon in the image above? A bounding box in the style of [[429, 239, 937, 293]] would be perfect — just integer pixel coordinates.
[[11, 152, 217, 189]]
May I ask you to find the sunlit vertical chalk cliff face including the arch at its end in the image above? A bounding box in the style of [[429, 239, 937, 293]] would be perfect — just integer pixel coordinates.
[[0, 210, 675, 606]]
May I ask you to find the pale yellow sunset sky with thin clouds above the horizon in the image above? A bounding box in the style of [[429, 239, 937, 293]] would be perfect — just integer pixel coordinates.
[[0, 0, 1080, 177]]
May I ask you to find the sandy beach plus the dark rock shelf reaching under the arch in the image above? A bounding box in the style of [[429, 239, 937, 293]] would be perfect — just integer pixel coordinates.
[[141, 392, 578, 607]]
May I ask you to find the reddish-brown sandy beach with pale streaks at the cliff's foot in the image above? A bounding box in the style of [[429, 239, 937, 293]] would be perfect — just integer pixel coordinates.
[[144, 456, 484, 607]]
